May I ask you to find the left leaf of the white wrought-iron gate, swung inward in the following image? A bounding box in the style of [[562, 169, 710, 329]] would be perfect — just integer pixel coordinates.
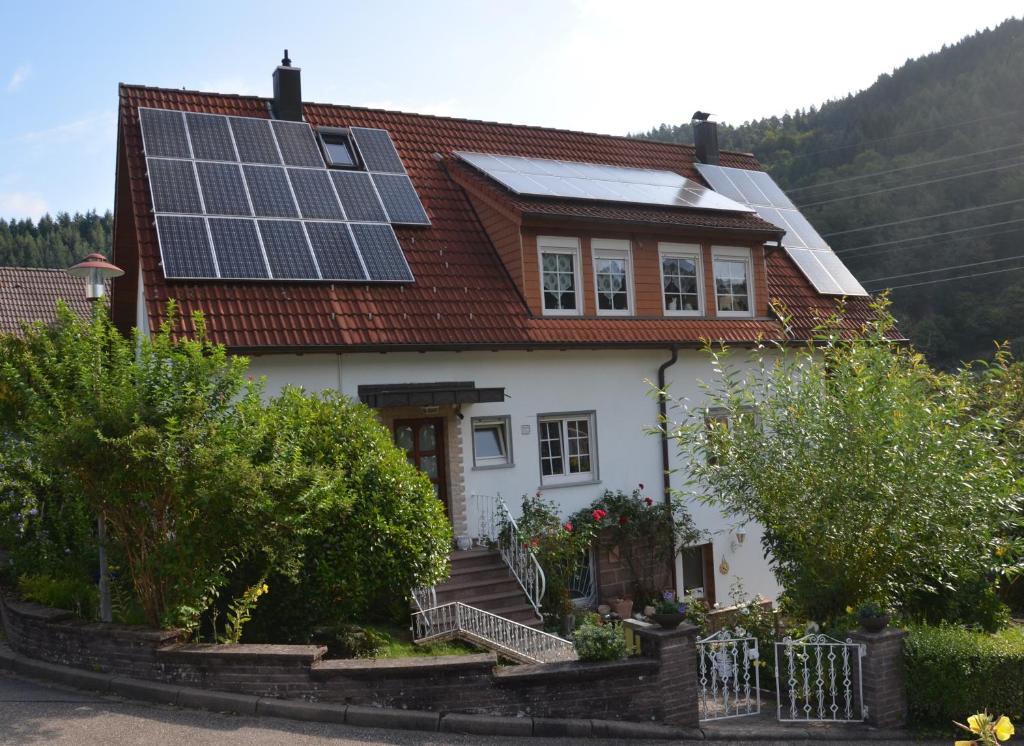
[[696, 629, 761, 720]]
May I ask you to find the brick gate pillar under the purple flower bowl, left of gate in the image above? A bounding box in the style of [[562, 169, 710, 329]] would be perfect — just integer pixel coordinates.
[[625, 619, 699, 728]]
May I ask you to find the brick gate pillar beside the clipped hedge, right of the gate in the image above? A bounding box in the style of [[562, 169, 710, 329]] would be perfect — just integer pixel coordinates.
[[850, 629, 906, 728]]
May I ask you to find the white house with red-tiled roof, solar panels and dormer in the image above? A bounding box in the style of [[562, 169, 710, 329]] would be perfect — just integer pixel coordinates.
[[112, 58, 870, 618]]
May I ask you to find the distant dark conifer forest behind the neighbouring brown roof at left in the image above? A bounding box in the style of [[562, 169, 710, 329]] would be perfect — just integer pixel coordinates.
[[0, 211, 114, 268]]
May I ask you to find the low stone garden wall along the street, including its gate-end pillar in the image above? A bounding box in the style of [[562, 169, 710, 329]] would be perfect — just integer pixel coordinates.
[[0, 594, 697, 727]]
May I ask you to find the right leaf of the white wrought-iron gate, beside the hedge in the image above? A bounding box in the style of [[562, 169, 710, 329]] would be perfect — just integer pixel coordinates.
[[775, 634, 867, 722]]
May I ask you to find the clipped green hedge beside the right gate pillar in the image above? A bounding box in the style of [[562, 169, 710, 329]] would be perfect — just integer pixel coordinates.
[[904, 625, 1024, 726]]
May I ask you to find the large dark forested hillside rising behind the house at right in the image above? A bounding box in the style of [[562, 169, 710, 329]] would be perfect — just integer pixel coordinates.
[[642, 19, 1024, 366]]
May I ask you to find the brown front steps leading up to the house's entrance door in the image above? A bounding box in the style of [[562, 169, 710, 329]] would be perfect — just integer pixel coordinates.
[[435, 548, 541, 628]]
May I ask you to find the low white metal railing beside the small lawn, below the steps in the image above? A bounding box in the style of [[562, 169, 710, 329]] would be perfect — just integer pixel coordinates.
[[413, 601, 577, 663]]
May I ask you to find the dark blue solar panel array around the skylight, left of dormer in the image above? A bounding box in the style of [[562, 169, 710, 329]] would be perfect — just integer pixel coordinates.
[[139, 107, 430, 282]]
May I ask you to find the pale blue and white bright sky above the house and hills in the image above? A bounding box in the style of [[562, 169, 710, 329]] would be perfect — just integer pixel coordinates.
[[0, 0, 1021, 219]]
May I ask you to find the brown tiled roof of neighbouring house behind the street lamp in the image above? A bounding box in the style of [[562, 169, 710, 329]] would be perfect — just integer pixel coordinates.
[[0, 267, 90, 335]]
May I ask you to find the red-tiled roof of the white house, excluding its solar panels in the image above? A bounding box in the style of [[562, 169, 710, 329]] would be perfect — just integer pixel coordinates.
[[114, 85, 880, 352]]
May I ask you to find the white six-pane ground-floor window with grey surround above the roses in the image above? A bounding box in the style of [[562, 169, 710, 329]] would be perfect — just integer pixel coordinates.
[[537, 411, 597, 486]]
